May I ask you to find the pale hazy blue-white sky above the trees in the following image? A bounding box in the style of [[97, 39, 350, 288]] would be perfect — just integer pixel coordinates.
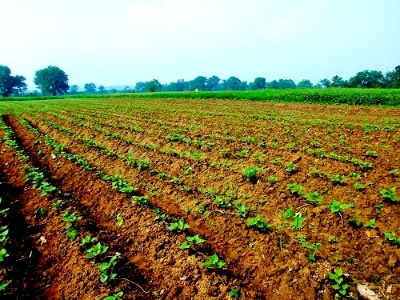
[[0, 0, 400, 88]]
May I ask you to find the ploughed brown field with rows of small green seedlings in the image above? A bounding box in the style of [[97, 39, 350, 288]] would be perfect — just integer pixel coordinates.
[[0, 96, 400, 300]]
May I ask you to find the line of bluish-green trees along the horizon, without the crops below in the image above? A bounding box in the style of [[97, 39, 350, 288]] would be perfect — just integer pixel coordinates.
[[0, 65, 400, 97]]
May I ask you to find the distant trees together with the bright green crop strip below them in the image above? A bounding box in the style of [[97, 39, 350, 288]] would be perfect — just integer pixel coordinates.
[[0, 65, 400, 106]]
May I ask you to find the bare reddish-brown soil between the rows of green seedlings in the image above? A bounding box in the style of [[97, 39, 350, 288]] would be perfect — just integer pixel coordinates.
[[0, 101, 400, 299]]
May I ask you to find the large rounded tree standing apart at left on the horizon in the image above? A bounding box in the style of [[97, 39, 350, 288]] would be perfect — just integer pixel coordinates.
[[33, 66, 69, 96]]
